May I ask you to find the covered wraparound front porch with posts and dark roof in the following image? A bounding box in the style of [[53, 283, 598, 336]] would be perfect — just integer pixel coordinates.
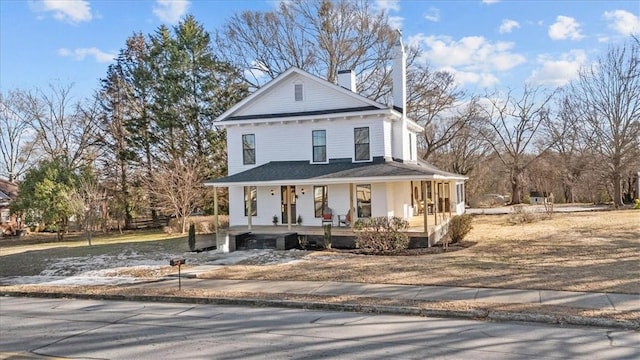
[[206, 162, 465, 246]]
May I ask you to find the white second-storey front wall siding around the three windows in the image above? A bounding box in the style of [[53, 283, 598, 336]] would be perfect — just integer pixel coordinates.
[[227, 119, 385, 175]]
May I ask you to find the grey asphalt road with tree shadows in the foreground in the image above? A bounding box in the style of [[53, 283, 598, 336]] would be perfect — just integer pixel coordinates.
[[0, 297, 640, 360]]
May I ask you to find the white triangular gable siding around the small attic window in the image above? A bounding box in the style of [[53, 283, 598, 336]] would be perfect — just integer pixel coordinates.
[[233, 74, 370, 116]]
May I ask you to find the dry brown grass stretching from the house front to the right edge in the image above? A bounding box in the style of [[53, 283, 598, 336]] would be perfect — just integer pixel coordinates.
[[205, 210, 640, 294]]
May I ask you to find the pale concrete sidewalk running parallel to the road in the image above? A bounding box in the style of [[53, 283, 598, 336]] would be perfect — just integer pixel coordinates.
[[130, 266, 640, 312]]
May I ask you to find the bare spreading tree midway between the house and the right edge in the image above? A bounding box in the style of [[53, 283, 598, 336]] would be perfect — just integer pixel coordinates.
[[479, 86, 555, 204]]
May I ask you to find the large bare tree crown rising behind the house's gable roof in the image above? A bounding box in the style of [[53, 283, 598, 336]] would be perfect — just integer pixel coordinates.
[[216, 0, 398, 100]]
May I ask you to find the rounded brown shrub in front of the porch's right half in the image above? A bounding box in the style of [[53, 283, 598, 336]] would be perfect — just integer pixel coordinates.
[[354, 216, 409, 254]]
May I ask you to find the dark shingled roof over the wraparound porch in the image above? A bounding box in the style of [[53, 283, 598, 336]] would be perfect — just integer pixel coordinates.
[[205, 158, 466, 186]]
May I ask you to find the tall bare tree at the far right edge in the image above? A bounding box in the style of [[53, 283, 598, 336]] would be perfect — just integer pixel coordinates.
[[571, 39, 640, 208]]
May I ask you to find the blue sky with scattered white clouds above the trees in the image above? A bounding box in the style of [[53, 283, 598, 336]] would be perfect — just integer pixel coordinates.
[[0, 0, 640, 97]]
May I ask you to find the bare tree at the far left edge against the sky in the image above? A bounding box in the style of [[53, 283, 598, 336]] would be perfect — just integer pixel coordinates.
[[0, 90, 33, 182]]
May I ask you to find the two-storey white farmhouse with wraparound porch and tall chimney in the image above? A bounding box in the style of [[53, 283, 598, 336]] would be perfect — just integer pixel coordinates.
[[205, 41, 466, 248]]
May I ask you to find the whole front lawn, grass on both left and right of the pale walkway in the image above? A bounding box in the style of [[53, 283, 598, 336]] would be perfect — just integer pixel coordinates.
[[0, 210, 640, 294]]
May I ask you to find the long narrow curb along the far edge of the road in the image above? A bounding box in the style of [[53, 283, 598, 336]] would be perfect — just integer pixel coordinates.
[[0, 290, 640, 330]]
